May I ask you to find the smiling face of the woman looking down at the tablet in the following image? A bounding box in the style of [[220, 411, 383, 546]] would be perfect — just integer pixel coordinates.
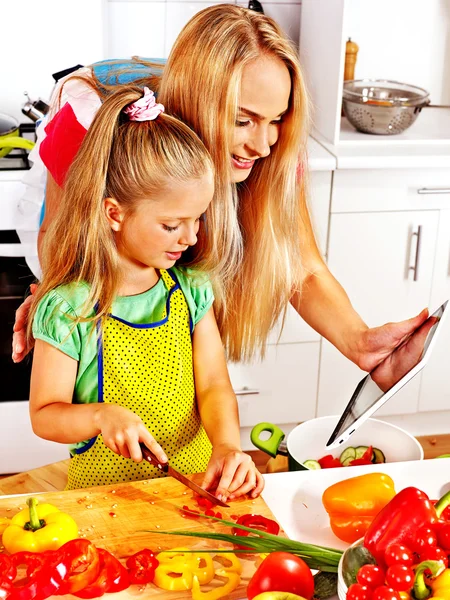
[[231, 56, 291, 183]]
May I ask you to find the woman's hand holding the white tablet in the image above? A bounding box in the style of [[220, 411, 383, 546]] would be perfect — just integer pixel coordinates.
[[350, 308, 428, 371]]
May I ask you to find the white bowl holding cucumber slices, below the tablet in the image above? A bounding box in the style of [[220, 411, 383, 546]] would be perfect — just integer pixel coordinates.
[[287, 416, 423, 472]]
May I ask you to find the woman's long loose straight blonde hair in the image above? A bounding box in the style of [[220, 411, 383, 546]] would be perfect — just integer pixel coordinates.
[[158, 4, 314, 360]]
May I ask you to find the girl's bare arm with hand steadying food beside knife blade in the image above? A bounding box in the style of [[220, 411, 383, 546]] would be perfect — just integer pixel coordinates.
[[193, 308, 264, 500]]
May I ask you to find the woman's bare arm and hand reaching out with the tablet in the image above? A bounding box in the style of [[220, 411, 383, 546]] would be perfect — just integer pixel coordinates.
[[291, 197, 428, 371]]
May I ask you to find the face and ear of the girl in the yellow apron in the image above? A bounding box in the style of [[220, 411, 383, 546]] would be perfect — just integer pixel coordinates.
[[105, 171, 214, 275]]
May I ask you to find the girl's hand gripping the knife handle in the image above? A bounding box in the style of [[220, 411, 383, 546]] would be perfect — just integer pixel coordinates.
[[94, 403, 168, 463]]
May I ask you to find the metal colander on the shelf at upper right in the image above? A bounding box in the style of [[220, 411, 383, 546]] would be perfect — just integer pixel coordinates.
[[342, 79, 430, 135]]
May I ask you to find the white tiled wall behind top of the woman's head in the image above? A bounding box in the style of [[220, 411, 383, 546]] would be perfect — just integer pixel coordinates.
[[106, 0, 301, 58]]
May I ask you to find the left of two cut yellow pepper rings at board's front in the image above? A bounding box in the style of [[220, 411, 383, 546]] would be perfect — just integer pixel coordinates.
[[153, 548, 214, 591]]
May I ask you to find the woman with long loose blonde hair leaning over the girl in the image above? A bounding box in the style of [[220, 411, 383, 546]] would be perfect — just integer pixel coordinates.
[[13, 5, 427, 390]]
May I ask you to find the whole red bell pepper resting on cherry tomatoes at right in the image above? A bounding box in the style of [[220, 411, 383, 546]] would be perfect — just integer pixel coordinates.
[[364, 487, 450, 565]]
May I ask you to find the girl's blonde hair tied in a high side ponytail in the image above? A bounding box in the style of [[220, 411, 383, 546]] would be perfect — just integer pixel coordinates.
[[28, 85, 214, 335]]
